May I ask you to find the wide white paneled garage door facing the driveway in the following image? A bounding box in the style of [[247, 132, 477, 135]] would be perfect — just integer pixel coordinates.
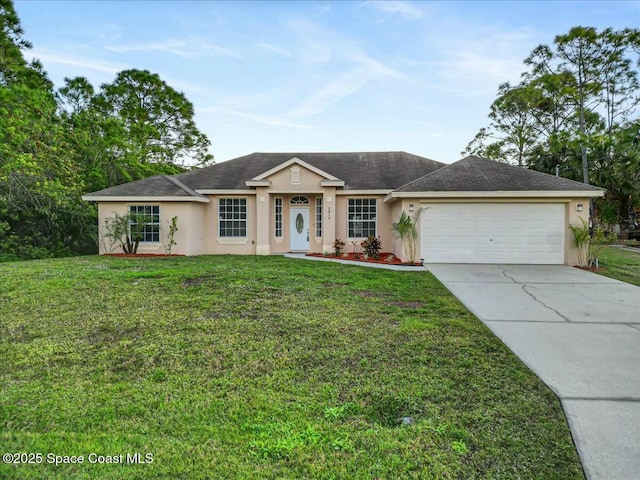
[[420, 203, 566, 264]]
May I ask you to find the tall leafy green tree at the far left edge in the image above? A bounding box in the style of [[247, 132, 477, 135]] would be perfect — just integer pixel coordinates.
[[0, 0, 94, 258]]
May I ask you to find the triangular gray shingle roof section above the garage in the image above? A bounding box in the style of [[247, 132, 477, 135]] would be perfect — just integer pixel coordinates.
[[395, 156, 603, 192]]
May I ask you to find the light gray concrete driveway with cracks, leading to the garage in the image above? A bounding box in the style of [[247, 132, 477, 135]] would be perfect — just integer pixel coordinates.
[[427, 264, 640, 480]]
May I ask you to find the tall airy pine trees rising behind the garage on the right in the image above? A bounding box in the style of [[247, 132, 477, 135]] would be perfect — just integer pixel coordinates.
[[467, 27, 640, 228]]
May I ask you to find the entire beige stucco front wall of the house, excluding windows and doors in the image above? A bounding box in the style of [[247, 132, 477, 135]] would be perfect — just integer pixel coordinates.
[[98, 175, 589, 265]]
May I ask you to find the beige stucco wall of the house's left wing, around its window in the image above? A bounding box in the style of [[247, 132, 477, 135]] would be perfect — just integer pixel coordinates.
[[98, 202, 205, 255]]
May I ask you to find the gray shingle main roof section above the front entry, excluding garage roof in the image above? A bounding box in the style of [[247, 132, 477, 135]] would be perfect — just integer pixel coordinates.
[[86, 152, 445, 197]]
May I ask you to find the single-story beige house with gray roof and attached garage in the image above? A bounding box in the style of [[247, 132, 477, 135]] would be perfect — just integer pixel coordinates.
[[83, 152, 604, 264]]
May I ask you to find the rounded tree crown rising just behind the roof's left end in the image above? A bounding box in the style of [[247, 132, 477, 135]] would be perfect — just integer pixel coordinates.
[[95, 69, 213, 166]]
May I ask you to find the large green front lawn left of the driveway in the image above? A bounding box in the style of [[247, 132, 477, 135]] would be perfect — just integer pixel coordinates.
[[0, 256, 584, 479]]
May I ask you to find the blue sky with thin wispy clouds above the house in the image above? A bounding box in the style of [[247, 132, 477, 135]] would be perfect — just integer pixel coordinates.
[[15, 0, 640, 163]]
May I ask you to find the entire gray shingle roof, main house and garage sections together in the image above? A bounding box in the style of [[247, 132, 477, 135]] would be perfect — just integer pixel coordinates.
[[85, 152, 602, 200]]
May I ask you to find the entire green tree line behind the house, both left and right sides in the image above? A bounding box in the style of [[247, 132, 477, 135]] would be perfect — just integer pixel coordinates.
[[0, 0, 640, 261]]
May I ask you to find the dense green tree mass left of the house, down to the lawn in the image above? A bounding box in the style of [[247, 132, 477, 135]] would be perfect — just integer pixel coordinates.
[[0, 0, 212, 261]]
